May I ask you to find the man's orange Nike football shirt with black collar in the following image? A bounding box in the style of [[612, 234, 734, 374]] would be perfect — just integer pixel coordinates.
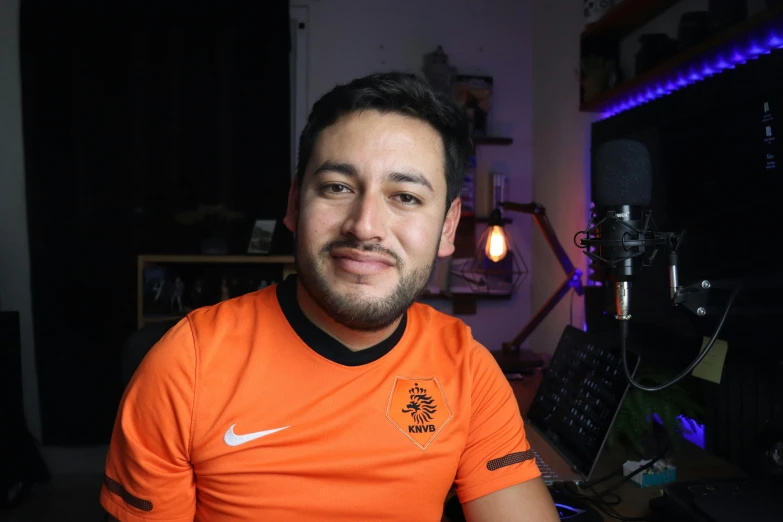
[[101, 276, 540, 522]]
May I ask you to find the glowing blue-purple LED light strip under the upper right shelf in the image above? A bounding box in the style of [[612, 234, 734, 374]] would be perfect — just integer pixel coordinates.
[[599, 15, 783, 119]]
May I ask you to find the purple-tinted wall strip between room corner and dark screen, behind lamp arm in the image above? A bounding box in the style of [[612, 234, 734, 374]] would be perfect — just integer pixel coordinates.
[[530, 0, 592, 353]]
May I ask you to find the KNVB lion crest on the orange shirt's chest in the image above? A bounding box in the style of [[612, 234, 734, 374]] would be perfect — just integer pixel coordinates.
[[386, 377, 452, 449]]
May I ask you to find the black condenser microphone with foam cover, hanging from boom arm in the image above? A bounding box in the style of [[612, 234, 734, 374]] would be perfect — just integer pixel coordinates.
[[587, 139, 657, 320]]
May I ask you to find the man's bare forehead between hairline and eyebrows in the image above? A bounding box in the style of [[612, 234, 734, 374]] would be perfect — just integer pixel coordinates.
[[307, 110, 446, 191]]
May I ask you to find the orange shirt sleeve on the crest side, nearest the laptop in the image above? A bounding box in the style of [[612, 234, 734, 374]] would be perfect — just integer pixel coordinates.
[[456, 345, 541, 504]]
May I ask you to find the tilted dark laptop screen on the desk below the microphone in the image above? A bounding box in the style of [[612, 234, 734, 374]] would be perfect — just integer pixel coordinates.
[[525, 325, 638, 485]]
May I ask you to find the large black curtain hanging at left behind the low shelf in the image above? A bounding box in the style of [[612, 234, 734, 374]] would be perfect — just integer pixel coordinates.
[[20, 0, 291, 445]]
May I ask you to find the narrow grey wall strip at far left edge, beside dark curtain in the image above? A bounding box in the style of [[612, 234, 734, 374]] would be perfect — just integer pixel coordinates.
[[0, 0, 41, 440]]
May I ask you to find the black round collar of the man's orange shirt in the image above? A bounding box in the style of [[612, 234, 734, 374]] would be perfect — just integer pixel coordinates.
[[277, 274, 408, 366]]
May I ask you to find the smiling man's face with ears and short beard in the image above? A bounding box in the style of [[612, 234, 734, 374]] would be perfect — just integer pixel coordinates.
[[284, 110, 460, 331]]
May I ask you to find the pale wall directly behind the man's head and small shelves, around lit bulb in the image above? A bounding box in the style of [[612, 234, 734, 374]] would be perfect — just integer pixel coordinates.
[[298, 0, 536, 350]]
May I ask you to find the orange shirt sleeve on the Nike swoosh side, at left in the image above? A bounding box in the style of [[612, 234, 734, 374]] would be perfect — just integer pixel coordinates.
[[100, 318, 198, 522]]
